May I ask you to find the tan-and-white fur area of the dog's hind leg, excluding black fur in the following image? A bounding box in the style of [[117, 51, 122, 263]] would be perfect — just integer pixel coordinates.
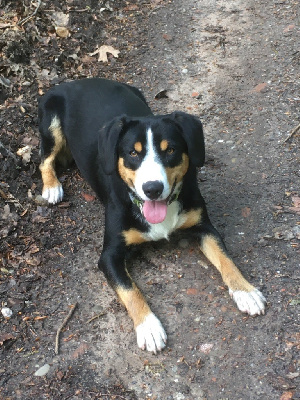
[[40, 117, 66, 204]]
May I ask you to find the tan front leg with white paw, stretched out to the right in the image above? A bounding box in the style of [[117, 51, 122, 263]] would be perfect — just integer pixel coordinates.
[[201, 235, 266, 315]]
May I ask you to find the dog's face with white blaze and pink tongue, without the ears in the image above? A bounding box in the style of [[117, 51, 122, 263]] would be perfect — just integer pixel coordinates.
[[118, 119, 189, 224]]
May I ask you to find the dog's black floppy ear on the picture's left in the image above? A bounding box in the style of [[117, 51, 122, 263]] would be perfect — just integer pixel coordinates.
[[98, 116, 126, 175]]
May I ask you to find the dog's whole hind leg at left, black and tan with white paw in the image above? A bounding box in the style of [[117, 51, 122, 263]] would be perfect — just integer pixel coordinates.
[[40, 116, 67, 204]]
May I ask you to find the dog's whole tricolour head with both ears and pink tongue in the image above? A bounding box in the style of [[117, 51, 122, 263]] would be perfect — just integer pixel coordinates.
[[99, 112, 205, 224]]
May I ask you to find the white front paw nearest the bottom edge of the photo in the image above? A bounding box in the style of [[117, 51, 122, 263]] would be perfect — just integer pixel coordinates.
[[135, 313, 167, 354]]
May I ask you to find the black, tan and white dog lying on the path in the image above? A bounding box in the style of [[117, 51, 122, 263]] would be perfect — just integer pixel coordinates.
[[39, 78, 266, 353]]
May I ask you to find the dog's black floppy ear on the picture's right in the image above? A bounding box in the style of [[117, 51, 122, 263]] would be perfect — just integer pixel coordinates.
[[171, 111, 205, 167]]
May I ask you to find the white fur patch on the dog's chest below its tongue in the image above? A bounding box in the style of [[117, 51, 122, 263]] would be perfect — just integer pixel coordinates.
[[145, 201, 186, 240]]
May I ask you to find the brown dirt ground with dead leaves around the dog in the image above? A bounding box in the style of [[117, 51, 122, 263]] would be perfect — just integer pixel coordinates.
[[0, 0, 300, 400]]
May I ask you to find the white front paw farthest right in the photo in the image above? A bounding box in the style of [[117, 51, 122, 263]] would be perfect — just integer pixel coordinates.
[[229, 289, 266, 315]]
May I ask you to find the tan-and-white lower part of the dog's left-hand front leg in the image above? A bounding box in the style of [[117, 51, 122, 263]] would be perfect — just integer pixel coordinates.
[[116, 283, 167, 353]]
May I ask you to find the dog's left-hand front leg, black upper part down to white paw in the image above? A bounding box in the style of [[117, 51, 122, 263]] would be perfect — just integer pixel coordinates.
[[99, 237, 167, 353]]
